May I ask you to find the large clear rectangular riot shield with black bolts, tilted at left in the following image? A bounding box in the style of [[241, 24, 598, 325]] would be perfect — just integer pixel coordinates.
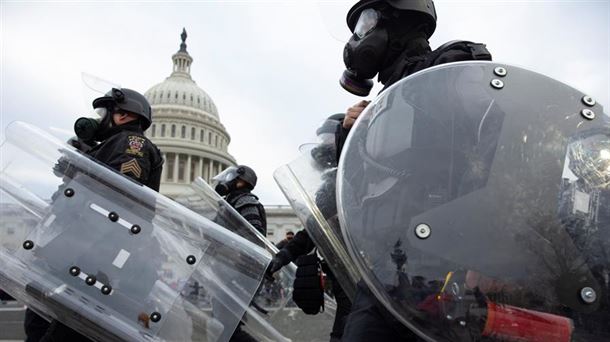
[[0, 122, 271, 341]]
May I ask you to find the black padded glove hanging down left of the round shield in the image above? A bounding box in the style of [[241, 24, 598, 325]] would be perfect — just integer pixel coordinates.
[[292, 254, 324, 315]]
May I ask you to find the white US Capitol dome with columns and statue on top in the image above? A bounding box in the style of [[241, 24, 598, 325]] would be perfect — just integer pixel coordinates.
[[144, 29, 236, 197]]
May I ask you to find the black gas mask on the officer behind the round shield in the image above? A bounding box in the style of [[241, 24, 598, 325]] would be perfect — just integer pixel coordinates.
[[339, 8, 389, 96]]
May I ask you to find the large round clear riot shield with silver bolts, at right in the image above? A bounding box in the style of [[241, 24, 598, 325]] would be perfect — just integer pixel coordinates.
[[338, 62, 610, 342]]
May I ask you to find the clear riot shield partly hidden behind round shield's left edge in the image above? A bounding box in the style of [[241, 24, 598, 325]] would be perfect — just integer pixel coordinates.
[[273, 144, 360, 300]]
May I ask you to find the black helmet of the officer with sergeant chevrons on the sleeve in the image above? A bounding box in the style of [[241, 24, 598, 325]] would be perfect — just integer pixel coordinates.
[[93, 88, 152, 130]]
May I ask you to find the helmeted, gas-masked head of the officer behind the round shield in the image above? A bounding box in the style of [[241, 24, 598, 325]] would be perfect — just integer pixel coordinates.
[[340, 0, 436, 96]]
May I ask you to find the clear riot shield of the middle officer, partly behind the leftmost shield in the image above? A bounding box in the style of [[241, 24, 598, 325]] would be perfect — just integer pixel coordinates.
[[176, 178, 336, 341]]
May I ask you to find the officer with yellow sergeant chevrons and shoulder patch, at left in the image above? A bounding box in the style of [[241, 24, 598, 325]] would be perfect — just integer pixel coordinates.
[[24, 88, 163, 341]]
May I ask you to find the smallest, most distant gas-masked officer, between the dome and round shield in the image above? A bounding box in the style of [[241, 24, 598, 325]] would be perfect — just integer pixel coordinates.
[[213, 165, 267, 236]]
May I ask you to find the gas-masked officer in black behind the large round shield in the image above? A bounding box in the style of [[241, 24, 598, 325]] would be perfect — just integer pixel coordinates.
[[330, 0, 491, 341]]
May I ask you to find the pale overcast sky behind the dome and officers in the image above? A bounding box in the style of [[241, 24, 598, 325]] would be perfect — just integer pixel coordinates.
[[0, 0, 610, 204]]
